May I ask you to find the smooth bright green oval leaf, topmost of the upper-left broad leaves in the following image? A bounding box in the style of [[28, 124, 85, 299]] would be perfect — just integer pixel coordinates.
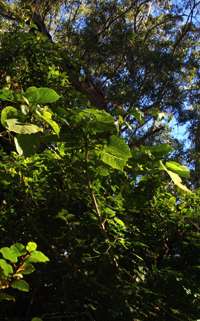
[[24, 87, 60, 104]]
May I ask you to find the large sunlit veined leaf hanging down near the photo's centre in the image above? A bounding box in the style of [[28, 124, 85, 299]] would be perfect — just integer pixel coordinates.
[[100, 136, 131, 171]]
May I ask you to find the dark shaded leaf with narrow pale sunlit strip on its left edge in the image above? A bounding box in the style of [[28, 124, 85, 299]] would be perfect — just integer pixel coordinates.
[[14, 133, 41, 157]]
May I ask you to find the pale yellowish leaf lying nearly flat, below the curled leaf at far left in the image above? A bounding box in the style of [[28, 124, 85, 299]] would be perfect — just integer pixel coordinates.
[[7, 119, 43, 135]]
